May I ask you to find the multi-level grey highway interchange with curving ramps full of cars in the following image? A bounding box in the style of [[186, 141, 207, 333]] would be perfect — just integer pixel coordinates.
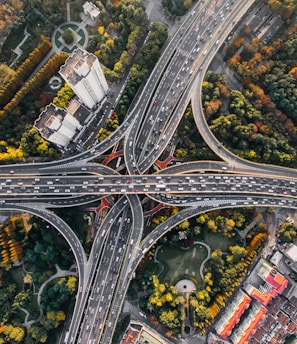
[[0, 0, 297, 344]]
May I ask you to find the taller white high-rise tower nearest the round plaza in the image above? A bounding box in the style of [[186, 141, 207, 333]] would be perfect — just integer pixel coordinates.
[[59, 48, 109, 109]]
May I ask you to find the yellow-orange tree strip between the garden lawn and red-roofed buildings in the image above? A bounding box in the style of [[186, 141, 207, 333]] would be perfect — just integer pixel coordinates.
[[190, 227, 267, 334]]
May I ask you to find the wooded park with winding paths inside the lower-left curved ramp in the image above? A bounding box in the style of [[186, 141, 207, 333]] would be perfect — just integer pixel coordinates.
[[0, 217, 77, 344]]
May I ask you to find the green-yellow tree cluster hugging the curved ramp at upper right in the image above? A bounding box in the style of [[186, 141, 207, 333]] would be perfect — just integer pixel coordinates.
[[202, 73, 297, 167]]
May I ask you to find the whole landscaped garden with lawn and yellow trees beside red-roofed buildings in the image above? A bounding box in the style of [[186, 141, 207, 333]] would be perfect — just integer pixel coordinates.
[[130, 207, 267, 337]]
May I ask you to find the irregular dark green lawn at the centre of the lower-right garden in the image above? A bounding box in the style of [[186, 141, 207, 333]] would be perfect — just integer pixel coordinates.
[[157, 244, 207, 284]]
